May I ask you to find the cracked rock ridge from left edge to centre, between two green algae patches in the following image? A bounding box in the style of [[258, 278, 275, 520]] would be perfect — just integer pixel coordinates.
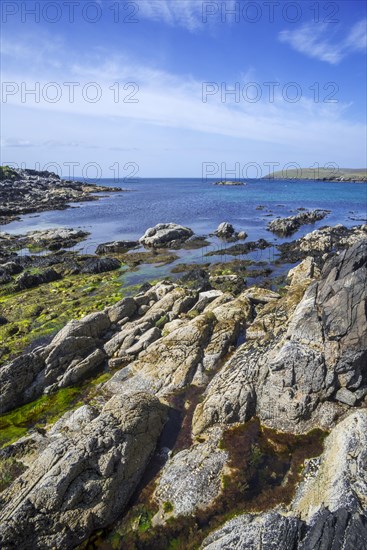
[[0, 281, 251, 412]]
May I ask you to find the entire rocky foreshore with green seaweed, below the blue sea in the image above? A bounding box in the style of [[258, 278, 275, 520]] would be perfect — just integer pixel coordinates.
[[0, 169, 367, 550]]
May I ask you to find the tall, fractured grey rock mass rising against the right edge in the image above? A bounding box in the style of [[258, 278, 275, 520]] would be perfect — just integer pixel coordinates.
[[193, 240, 367, 433]]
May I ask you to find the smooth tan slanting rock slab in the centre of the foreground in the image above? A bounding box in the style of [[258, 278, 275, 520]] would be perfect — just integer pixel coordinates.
[[106, 289, 251, 402]]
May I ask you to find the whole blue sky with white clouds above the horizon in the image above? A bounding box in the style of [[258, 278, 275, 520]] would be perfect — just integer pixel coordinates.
[[0, 0, 367, 179]]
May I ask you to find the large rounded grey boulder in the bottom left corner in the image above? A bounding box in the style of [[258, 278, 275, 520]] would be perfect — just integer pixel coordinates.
[[0, 393, 166, 550]]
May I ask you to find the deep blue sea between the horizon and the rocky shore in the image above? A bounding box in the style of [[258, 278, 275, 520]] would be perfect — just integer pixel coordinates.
[[1, 178, 367, 281]]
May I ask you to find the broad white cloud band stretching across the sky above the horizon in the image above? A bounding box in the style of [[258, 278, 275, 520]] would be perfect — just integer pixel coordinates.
[[2, 32, 365, 174]]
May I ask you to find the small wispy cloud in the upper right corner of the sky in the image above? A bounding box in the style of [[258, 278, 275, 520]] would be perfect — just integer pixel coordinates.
[[279, 19, 367, 65]]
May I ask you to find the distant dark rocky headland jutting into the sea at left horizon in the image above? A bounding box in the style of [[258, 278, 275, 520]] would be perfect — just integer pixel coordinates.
[[0, 166, 121, 224]]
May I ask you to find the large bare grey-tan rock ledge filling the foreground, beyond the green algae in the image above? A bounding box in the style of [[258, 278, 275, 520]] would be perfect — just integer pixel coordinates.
[[0, 228, 367, 550]]
